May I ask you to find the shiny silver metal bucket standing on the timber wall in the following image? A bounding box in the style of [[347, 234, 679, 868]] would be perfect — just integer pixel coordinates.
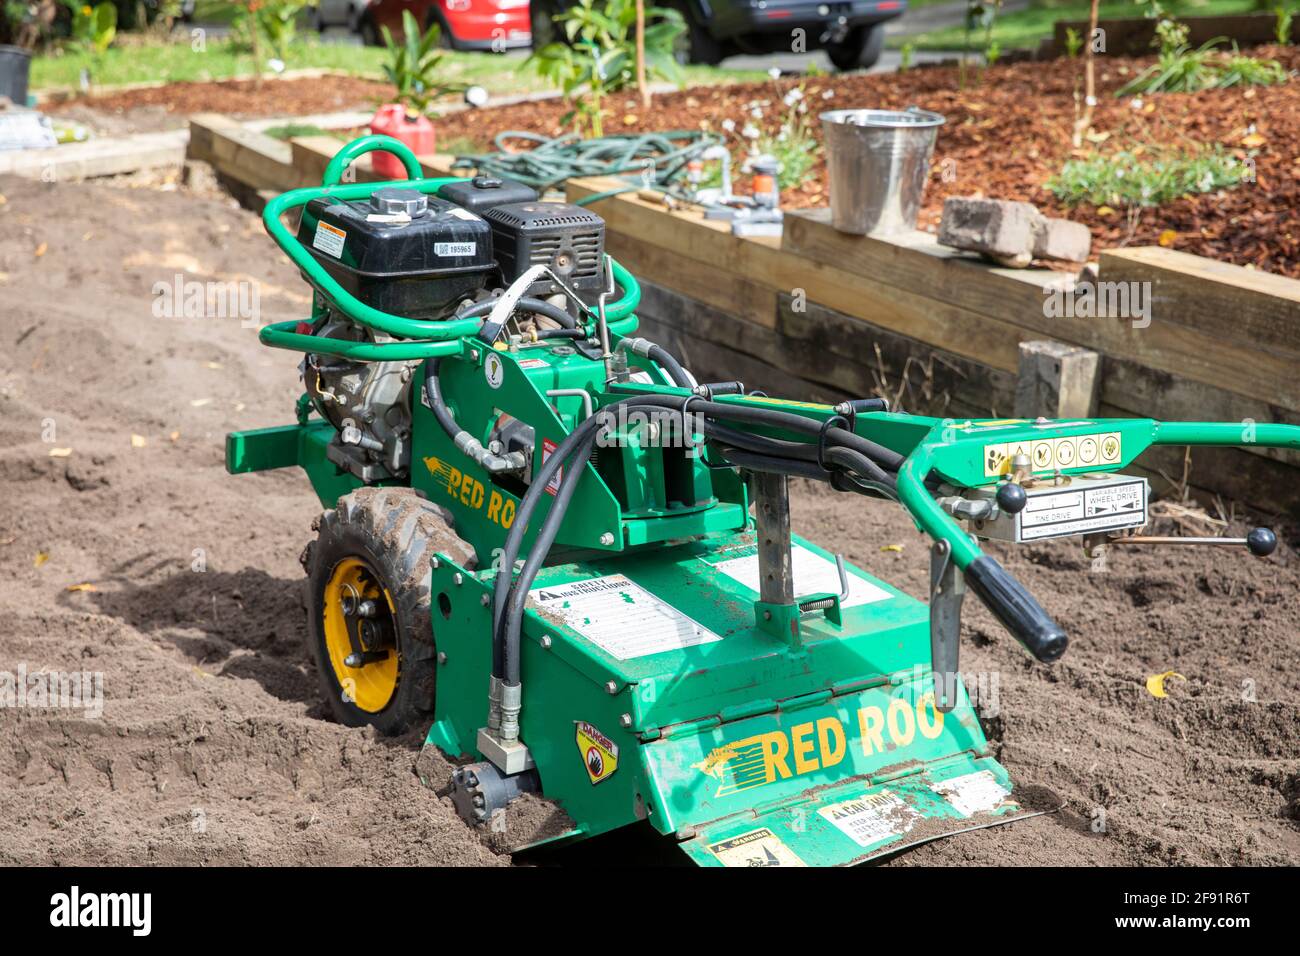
[[822, 107, 944, 235]]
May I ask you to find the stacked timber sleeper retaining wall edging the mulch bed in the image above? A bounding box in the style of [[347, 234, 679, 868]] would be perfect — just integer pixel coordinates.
[[191, 117, 1300, 514]]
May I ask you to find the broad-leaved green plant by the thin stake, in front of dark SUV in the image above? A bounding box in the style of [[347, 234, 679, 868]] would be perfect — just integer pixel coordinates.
[[524, 0, 686, 137]]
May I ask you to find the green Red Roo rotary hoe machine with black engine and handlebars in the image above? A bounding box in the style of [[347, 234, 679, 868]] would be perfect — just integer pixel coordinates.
[[226, 137, 1300, 866]]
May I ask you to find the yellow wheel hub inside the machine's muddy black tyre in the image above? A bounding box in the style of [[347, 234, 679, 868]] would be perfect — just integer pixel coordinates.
[[321, 558, 398, 714]]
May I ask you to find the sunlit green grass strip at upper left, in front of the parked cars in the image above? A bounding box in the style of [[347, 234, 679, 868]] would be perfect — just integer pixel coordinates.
[[31, 35, 766, 94]]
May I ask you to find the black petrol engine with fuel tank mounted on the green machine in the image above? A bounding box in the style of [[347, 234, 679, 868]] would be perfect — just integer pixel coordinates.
[[298, 177, 605, 483]]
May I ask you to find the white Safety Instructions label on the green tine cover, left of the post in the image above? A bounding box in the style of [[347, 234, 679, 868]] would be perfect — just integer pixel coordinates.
[[529, 575, 722, 661]]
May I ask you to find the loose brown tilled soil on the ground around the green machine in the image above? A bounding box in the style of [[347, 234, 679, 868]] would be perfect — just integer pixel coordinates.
[[0, 179, 1300, 865]]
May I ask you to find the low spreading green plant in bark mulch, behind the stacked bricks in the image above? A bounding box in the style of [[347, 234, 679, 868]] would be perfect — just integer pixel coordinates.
[[1045, 146, 1249, 208]]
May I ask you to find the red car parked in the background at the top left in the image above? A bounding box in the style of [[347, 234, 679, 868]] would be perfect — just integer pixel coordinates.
[[313, 0, 532, 52]]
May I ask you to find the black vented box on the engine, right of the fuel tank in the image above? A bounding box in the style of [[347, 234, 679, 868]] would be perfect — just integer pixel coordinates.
[[482, 203, 605, 295]]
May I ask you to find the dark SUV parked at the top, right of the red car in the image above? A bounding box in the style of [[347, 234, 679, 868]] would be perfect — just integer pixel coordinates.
[[530, 0, 907, 70]]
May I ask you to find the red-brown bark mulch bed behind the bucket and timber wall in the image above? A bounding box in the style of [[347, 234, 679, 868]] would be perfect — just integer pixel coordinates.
[[438, 47, 1300, 277]]
